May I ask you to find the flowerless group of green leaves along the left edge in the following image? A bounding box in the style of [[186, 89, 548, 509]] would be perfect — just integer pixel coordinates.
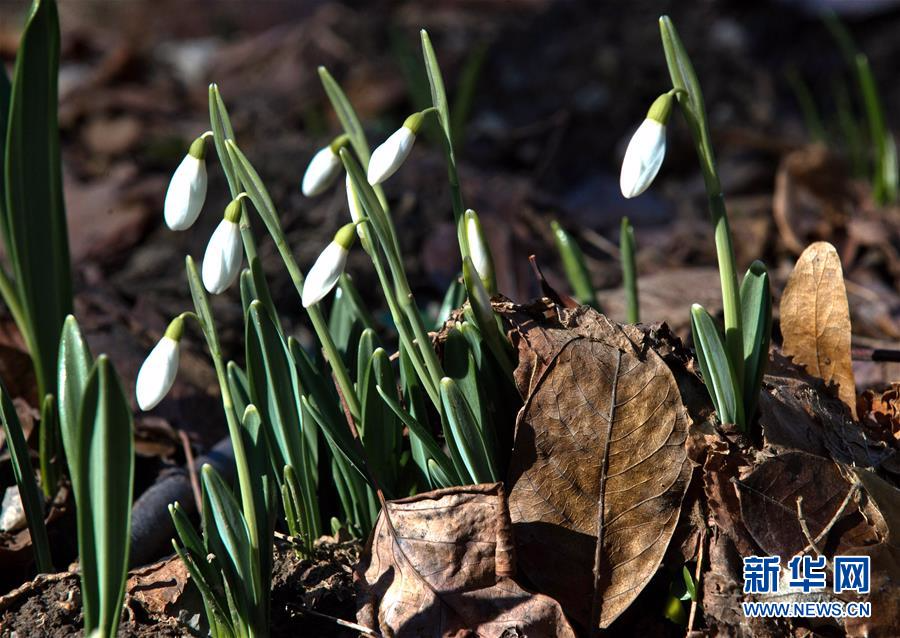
[[0, 0, 134, 638]]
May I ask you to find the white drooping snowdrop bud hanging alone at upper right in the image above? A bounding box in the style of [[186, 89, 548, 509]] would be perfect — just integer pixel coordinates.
[[619, 91, 674, 199]]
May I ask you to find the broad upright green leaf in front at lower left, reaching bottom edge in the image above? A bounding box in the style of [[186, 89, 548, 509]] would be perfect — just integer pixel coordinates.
[[76, 355, 134, 636]]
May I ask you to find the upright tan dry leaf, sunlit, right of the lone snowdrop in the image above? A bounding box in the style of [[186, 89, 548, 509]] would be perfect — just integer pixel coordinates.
[[781, 242, 856, 418]]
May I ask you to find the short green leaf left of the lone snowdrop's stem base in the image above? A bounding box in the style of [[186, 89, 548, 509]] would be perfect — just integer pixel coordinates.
[[691, 304, 744, 429]]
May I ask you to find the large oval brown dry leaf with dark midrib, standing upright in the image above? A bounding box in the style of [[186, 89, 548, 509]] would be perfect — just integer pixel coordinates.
[[507, 306, 691, 627]]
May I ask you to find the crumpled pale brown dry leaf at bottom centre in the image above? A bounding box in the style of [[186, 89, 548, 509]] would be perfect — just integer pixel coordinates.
[[357, 483, 575, 638]]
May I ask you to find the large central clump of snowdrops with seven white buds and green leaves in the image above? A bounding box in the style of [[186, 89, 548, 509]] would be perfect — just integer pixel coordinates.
[[129, 31, 519, 636]]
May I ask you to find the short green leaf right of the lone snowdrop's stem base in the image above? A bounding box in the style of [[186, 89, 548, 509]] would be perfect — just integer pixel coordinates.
[[741, 261, 772, 422]]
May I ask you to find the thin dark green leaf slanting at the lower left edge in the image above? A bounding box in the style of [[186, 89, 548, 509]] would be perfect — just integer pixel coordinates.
[[0, 379, 53, 574]]
